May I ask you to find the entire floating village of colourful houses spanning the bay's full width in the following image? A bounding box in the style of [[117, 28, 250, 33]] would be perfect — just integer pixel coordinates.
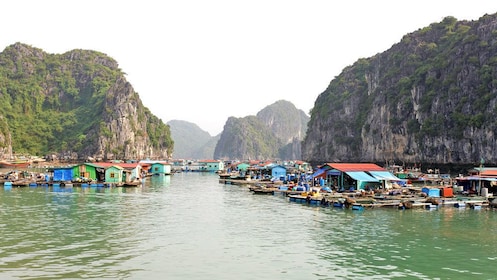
[[0, 160, 497, 210]]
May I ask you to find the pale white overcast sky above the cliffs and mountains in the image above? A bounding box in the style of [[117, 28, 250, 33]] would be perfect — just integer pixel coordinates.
[[0, 0, 497, 136]]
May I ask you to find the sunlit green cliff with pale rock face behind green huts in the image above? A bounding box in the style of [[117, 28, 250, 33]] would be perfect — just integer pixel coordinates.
[[0, 43, 173, 160]]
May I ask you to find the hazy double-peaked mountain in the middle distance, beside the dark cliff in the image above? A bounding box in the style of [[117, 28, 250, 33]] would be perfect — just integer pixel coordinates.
[[214, 100, 309, 160]]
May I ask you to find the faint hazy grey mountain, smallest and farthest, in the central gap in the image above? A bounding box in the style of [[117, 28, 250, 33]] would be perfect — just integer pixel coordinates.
[[167, 120, 219, 159]]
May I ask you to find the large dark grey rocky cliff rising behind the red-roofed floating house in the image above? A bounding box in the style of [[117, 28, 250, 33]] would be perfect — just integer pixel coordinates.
[[302, 14, 497, 164]]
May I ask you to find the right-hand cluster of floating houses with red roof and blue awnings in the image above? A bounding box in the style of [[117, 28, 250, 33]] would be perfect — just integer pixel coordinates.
[[219, 161, 497, 210]]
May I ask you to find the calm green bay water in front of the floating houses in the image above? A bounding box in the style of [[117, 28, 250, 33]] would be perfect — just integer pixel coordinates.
[[0, 173, 497, 279]]
